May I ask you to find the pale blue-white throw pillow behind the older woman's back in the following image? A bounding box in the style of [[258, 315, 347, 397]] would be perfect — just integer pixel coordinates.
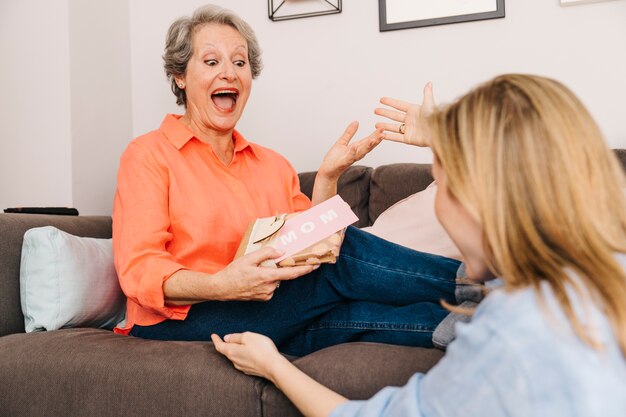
[[20, 226, 126, 332]]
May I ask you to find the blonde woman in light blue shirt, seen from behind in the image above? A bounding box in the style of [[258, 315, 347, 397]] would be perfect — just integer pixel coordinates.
[[213, 74, 626, 417]]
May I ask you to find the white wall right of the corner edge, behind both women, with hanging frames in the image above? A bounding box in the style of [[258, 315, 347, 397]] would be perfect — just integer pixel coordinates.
[[130, 0, 626, 170]]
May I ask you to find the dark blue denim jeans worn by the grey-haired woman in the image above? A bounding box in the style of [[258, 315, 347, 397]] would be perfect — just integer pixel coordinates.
[[131, 227, 459, 356]]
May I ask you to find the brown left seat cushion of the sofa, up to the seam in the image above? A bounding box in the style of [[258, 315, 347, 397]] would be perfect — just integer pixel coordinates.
[[0, 329, 265, 417]]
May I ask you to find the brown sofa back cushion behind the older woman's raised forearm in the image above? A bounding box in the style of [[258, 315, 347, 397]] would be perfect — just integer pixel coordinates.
[[298, 165, 372, 227]]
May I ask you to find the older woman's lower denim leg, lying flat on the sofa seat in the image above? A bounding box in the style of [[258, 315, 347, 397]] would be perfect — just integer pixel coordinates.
[[280, 301, 449, 356]]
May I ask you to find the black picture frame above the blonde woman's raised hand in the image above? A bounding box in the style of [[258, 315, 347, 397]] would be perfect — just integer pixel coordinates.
[[378, 0, 504, 32]]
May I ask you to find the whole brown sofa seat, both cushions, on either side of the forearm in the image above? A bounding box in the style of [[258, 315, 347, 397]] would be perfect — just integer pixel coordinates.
[[0, 329, 442, 417]]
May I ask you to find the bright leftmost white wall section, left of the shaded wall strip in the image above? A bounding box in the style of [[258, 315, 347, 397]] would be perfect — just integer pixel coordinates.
[[0, 0, 72, 209]]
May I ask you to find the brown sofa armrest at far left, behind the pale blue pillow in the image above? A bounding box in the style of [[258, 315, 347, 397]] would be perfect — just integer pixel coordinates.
[[0, 213, 112, 336]]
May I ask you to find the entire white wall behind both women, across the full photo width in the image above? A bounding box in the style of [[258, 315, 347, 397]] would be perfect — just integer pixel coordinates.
[[0, 0, 626, 214]]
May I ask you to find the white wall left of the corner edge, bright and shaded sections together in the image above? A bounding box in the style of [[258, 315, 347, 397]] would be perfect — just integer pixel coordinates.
[[0, 0, 132, 214]]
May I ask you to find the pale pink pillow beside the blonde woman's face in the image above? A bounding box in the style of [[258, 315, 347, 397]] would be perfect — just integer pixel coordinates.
[[363, 182, 461, 260]]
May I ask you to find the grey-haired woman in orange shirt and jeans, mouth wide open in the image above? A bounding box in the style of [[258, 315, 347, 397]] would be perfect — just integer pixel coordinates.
[[113, 6, 459, 355]]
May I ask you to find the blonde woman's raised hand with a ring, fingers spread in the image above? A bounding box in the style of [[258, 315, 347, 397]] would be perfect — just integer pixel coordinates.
[[374, 83, 435, 146]]
